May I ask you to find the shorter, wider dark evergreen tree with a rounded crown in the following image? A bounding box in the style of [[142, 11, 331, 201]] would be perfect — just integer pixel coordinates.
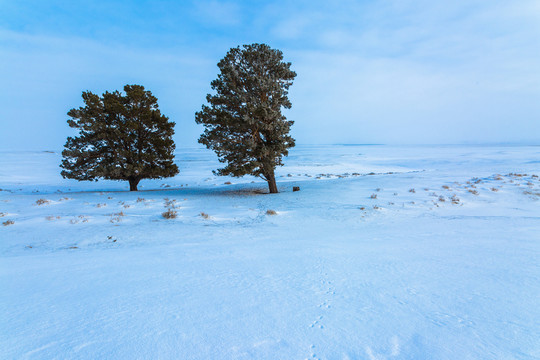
[[60, 85, 178, 191]]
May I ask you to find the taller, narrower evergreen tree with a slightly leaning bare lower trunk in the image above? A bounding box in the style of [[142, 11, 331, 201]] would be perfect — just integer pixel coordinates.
[[195, 44, 296, 193]]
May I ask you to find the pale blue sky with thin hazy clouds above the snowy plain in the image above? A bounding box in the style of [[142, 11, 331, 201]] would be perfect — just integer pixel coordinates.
[[0, 0, 540, 151]]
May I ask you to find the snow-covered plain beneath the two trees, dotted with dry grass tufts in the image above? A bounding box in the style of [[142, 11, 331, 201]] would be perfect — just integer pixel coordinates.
[[0, 146, 540, 360]]
